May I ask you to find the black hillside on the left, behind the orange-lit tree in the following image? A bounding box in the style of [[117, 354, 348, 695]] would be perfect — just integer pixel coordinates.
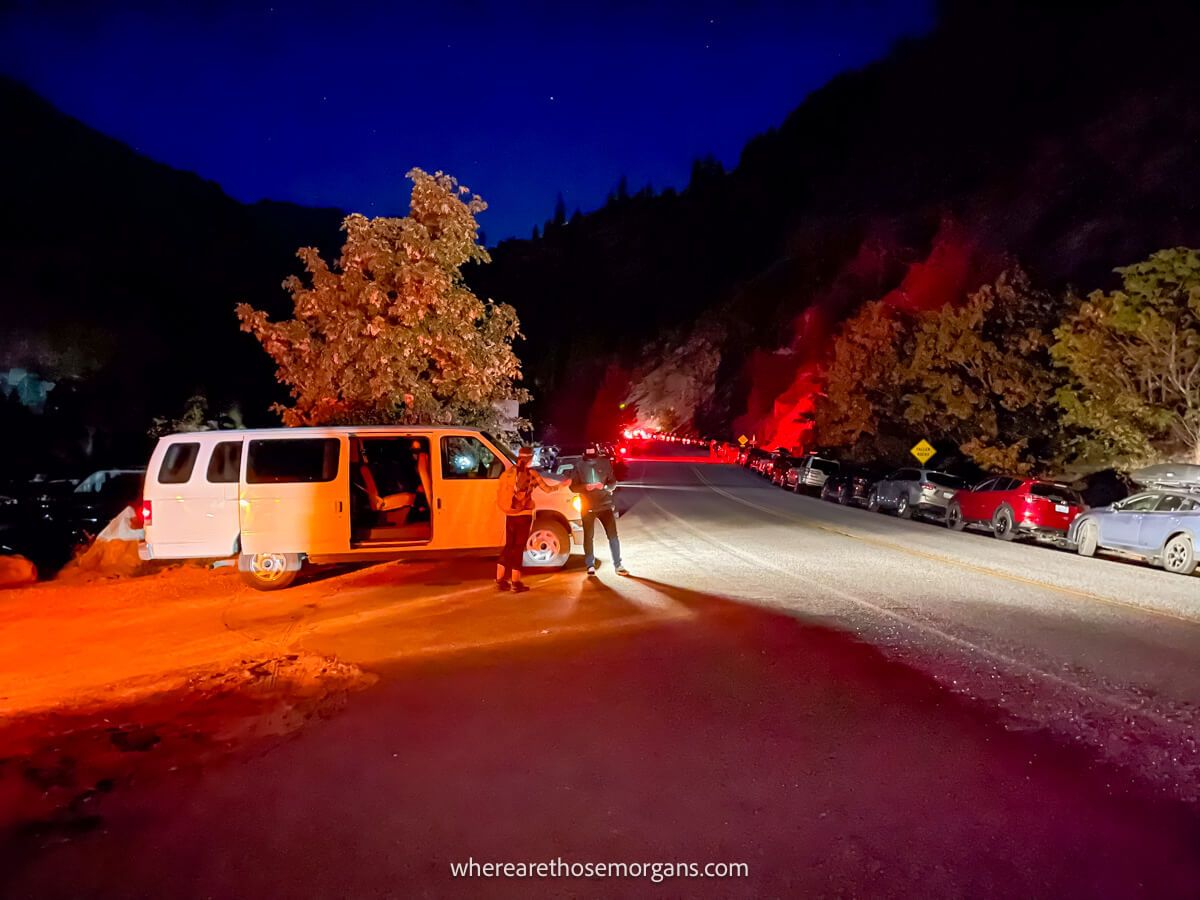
[[0, 79, 342, 468]]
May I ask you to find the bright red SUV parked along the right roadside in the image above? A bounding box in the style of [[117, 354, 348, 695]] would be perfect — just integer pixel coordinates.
[[946, 476, 1087, 541]]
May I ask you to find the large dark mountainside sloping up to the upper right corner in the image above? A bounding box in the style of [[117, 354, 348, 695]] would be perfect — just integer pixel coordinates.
[[479, 0, 1200, 431]]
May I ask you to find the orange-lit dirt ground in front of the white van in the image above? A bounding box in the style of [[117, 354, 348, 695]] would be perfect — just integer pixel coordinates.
[[0, 560, 654, 842]]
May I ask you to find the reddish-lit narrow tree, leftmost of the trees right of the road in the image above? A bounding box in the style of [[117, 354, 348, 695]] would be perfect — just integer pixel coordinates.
[[812, 301, 905, 448]]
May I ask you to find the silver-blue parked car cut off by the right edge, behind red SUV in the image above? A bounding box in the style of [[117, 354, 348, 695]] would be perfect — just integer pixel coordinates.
[[1067, 464, 1200, 575]]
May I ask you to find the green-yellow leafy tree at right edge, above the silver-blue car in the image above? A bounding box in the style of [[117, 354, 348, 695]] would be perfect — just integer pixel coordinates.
[[1052, 247, 1200, 464]]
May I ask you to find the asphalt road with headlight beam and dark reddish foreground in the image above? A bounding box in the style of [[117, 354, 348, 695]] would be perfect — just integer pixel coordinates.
[[11, 461, 1200, 896]]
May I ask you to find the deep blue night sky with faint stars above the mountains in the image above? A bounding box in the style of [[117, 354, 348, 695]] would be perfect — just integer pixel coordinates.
[[0, 0, 934, 242]]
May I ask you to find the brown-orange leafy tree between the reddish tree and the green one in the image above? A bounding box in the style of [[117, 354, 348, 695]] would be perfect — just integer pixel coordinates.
[[896, 269, 1057, 473]]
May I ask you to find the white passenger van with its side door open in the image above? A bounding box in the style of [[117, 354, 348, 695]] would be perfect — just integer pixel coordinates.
[[140, 426, 582, 590]]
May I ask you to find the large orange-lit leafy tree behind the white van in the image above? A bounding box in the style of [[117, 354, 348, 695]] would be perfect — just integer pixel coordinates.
[[238, 169, 528, 434]]
